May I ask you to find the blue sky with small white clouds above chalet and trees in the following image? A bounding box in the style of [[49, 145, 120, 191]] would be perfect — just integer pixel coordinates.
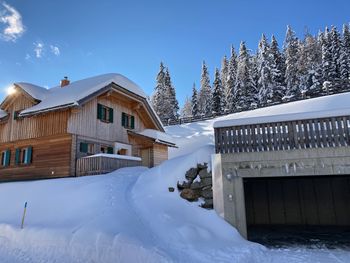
[[0, 0, 350, 104]]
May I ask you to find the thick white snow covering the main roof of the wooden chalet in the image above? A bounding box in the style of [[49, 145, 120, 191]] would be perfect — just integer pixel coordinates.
[[18, 73, 147, 115]]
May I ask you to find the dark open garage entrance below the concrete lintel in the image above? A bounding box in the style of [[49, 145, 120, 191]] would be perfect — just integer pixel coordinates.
[[243, 175, 350, 246]]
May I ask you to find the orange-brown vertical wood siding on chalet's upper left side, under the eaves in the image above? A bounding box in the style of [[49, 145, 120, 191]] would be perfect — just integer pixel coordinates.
[[0, 93, 69, 143]]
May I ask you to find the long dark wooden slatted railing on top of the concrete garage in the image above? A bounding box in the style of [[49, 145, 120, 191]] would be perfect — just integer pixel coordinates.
[[215, 116, 350, 153]]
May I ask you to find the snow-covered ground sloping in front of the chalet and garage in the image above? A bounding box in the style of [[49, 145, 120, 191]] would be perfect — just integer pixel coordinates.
[[0, 118, 350, 263]]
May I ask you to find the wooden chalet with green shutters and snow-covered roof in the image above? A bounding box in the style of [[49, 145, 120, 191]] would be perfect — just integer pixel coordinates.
[[0, 73, 175, 181]]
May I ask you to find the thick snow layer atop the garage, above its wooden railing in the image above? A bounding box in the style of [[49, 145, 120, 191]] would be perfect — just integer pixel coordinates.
[[214, 92, 350, 128]]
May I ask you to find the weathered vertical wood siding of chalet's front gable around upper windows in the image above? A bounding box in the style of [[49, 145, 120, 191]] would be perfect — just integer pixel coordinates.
[[68, 98, 145, 143]]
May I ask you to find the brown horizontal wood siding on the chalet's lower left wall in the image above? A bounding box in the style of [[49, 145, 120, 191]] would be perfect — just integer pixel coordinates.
[[0, 135, 72, 181]]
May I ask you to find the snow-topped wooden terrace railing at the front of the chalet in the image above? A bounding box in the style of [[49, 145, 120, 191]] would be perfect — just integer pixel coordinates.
[[77, 154, 141, 176]]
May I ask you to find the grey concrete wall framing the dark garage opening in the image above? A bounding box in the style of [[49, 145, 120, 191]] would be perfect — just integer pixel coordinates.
[[212, 147, 350, 240]]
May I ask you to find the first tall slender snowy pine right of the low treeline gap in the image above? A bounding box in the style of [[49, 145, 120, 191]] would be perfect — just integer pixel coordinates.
[[198, 61, 212, 116]]
